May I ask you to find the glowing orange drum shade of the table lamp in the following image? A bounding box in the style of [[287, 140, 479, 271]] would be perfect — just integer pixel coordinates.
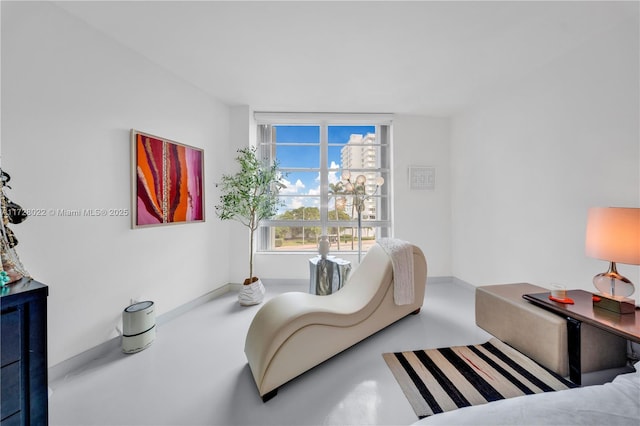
[[585, 207, 640, 265]]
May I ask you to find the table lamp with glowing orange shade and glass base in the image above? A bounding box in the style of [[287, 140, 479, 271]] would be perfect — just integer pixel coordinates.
[[585, 207, 640, 313]]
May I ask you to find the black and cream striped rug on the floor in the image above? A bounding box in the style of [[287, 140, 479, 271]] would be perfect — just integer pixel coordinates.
[[382, 339, 576, 418]]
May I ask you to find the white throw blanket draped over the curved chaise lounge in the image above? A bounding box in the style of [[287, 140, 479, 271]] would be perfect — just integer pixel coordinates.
[[377, 238, 414, 305]]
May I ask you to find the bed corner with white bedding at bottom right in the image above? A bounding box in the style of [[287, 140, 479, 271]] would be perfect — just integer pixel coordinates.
[[414, 362, 640, 426]]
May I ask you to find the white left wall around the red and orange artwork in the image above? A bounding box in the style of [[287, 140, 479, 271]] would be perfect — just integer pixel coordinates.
[[2, 2, 229, 365]]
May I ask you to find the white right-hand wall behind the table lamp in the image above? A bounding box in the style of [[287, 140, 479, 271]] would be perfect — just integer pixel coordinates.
[[452, 17, 640, 290]]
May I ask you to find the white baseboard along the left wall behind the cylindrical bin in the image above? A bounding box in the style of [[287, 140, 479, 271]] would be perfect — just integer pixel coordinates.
[[48, 283, 236, 383]]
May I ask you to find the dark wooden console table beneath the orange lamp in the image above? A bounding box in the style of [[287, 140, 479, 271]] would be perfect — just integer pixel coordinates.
[[522, 290, 640, 384]]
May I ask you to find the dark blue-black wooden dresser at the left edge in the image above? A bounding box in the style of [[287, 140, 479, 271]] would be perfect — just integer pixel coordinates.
[[0, 278, 49, 426]]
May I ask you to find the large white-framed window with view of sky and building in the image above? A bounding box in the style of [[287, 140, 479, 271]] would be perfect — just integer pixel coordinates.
[[255, 113, 392, 253]]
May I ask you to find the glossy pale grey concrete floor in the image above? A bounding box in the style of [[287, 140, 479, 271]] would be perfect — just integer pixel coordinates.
[[49, 280, 490, 426]]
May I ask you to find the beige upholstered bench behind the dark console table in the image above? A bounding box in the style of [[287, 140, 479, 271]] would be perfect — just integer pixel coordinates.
[[476, 283, 627, 377]]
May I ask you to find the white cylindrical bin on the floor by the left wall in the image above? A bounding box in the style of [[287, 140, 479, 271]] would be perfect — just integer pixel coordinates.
[[122, 301, 156, 354]]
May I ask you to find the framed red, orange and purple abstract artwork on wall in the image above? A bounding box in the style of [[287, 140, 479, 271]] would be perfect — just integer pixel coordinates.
[[132, 130, 204, 227]]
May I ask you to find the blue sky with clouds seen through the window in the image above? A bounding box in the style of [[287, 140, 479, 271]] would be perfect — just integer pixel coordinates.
[[275, 126, 376, 210]]
